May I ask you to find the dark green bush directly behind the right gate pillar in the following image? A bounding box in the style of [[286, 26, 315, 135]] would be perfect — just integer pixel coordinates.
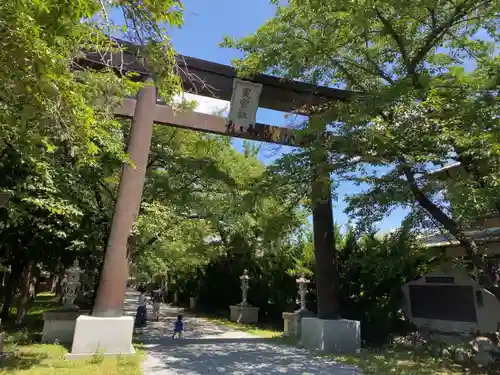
[[290, 222, 440, 344]]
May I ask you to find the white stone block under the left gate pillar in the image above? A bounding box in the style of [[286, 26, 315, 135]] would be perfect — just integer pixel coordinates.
[[66, 316, 135, 359]]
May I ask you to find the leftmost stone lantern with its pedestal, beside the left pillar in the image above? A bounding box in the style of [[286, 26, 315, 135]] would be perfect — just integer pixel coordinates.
[[42, 259, 89, 344]]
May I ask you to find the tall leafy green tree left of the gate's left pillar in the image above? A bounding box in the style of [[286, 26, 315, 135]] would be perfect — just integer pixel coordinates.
[[0, 0, 182, 322]]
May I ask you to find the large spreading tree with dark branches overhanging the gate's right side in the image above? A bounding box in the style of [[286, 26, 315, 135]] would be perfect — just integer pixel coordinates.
[[223, 0, 500, 282]]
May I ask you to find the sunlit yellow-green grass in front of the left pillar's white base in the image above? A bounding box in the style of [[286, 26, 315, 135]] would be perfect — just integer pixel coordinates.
[[0, 344, 143, 375]]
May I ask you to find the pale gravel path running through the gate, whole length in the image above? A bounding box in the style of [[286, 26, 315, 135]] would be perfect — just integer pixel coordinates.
[[125, 292, 359, 375]]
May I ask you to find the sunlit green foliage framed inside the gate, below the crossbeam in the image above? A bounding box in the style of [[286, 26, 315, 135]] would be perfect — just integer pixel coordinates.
[[134, 123, 305, 280]]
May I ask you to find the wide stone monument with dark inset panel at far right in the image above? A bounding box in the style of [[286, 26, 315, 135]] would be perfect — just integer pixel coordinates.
[[403, 269, 500, 336]]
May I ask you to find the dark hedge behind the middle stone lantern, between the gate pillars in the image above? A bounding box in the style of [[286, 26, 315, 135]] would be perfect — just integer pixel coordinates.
[[169, 247, 301, 325]]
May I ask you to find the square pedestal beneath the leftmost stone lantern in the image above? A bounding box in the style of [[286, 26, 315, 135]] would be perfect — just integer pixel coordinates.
[[42, 309, 89, 344]]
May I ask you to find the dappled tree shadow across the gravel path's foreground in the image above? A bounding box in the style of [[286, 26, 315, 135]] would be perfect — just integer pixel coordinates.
[[145, 338, 358, 375]]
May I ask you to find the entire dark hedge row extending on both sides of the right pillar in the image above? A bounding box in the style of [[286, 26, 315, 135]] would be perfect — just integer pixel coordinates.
[[170, 223, 440, 343]]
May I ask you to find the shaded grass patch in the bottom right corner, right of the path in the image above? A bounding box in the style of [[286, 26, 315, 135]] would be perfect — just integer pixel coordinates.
[[334, 346, 490, 375]]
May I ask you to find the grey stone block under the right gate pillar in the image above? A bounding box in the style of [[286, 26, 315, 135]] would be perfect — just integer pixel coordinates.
[[300, 318, 361, 354]]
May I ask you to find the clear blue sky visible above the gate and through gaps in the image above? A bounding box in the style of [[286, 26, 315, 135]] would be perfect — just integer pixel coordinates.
[[112, 0, 412, 231]]
